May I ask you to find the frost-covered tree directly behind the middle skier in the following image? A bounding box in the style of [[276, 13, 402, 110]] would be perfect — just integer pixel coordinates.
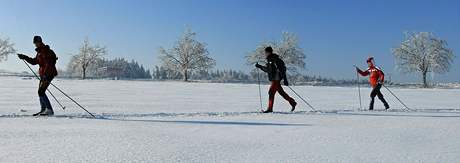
[[246, 32, 306, 82]]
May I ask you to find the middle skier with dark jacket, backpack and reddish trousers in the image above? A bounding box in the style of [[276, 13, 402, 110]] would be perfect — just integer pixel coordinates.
[[256, 47, 297, 113]]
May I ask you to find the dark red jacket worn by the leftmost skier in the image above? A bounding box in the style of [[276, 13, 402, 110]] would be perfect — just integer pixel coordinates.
[[26, 45, 57, 77]]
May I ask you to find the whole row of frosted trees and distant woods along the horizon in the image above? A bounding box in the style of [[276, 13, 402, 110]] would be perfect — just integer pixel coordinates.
[[0, 29, 455, 87]]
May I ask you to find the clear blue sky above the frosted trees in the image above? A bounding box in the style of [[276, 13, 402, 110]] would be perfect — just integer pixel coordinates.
[[0, 0, 460, 82]]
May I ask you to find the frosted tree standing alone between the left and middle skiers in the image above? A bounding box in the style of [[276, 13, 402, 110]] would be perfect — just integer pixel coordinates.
[[159, 29, 216, 81]]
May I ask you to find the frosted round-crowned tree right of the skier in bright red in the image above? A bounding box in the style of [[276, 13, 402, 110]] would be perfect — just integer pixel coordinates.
[[392, 32, 455, 87]]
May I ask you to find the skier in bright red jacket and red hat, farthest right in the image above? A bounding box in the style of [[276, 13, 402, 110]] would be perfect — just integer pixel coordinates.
[[356, 57, 390, 110]]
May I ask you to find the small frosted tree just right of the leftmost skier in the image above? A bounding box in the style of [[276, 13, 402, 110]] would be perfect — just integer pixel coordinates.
[[68, 39, 107, 79]]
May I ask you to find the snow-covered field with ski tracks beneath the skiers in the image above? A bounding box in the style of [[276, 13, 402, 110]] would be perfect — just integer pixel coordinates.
[[0, 77, 460, 163]]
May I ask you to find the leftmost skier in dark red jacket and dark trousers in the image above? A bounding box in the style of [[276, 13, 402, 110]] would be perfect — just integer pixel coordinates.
[[18, 36, 57, 116]]
